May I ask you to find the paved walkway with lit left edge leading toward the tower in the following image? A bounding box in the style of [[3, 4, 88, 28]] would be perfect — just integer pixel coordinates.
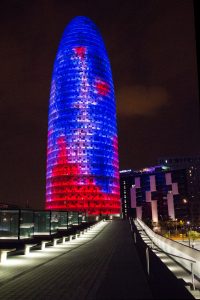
[[0, 220, 152, 300]]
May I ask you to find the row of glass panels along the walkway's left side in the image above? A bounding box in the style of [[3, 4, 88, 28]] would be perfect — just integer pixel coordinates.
[[0, 209, 87, 240]]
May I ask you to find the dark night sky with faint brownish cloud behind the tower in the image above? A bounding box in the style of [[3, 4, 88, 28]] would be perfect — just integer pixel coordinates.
[[0, 0, 200, 208]]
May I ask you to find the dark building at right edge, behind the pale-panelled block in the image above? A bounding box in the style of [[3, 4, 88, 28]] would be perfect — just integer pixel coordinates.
[[158, 156, 200, 224]]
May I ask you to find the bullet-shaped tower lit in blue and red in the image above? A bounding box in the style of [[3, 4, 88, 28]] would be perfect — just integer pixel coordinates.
[[46, 17, 120, 215]]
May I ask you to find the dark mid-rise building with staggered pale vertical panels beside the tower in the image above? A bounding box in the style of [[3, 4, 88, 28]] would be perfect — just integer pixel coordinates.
[[120, 165, 189, 223]]
